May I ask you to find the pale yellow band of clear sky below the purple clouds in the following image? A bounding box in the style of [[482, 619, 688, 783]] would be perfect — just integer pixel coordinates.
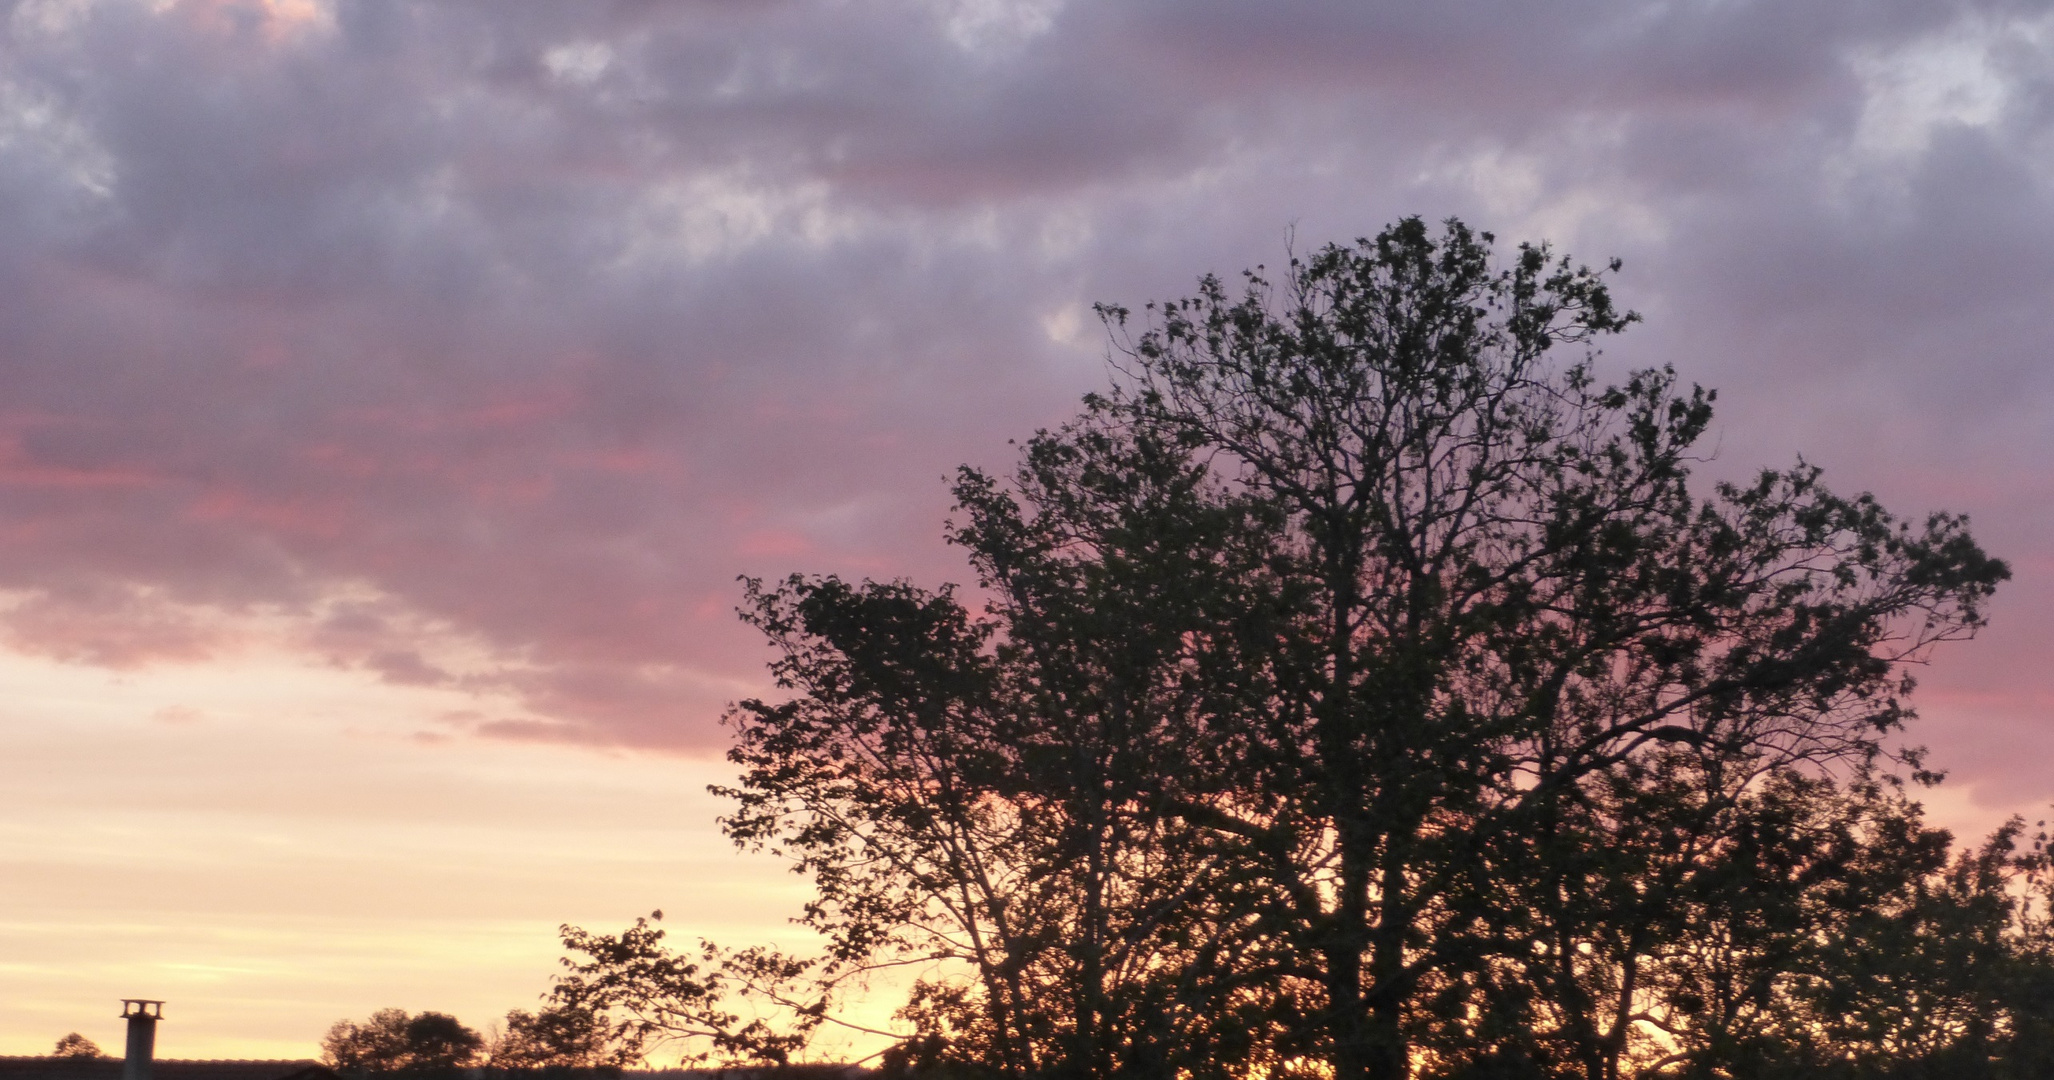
[[0, 655, 850, 1057]]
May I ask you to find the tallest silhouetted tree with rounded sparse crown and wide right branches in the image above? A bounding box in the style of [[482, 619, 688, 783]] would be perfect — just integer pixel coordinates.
[[1095, 220, 2009, 1080]]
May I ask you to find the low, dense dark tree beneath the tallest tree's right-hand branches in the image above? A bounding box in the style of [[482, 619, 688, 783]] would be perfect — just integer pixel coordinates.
[[1452, 763, 2017, 1078]]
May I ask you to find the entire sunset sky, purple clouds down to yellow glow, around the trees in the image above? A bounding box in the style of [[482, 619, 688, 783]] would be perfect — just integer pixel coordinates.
[[0, 0, 2054, 1057]]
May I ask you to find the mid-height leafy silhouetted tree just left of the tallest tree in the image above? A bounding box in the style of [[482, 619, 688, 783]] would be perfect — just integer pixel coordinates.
[[725, 433, 1278, 1076]]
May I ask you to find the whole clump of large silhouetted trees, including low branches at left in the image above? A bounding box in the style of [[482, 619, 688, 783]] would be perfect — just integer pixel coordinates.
[[548, 220, 2054, 1080]]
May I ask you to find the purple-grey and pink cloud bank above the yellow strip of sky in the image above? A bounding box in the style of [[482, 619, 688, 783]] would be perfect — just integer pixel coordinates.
[[0, 0, 2054, 817]]
